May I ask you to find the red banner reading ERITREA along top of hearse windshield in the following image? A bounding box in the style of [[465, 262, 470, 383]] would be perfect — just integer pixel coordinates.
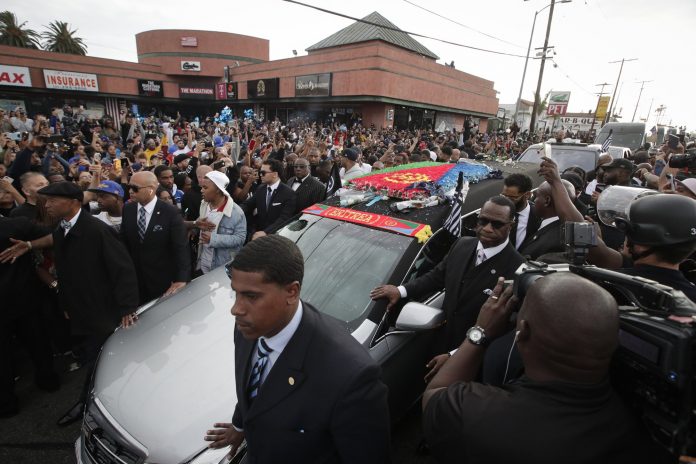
[[302, 203, 432, 242]]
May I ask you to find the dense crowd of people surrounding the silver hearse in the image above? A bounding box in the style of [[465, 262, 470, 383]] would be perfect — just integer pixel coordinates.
[[0, 106, 696, 463]]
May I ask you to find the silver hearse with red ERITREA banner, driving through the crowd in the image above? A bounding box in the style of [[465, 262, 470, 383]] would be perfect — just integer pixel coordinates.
[[75, 163, 539, 464]]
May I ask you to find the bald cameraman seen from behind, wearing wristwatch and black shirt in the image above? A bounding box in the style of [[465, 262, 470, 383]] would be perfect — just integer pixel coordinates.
[[423, 272, 656, 464]]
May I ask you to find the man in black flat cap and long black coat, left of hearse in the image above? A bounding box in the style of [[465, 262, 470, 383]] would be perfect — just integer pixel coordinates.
[[38, 182, 138, 426]]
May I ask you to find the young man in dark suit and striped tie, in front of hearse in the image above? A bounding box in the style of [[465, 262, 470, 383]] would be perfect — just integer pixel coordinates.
[[205, 235, 390, 464]]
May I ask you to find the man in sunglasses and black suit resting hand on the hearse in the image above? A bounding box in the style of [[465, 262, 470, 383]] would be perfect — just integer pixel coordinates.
[[370, 196, 524, 380]]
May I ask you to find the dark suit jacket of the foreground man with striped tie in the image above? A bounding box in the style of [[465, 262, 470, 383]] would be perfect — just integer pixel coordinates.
[[232, 302, 390, 464]]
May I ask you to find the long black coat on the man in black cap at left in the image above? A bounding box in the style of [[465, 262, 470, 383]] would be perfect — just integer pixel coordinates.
[[53, 211, 138, 335]]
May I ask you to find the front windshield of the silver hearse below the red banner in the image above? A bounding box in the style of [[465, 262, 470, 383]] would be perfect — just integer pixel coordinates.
[[280, 218, 414, 326]]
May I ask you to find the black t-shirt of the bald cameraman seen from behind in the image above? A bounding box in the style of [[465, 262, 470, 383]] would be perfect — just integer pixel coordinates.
[[423, 377, 655, 464]]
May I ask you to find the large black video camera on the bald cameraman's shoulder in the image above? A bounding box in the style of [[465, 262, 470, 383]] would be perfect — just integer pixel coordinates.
[[513, 260, 696, 461]]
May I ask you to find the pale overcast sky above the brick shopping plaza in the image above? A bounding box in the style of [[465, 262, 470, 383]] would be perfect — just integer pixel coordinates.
[[2, 0, 696, 131]]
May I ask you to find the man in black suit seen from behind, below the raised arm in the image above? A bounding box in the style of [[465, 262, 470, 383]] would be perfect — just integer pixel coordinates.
[[517, 179, 575, 259]]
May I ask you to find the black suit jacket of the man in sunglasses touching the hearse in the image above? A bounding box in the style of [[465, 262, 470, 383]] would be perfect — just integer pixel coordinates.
[[404, 237, 524, 351]]
